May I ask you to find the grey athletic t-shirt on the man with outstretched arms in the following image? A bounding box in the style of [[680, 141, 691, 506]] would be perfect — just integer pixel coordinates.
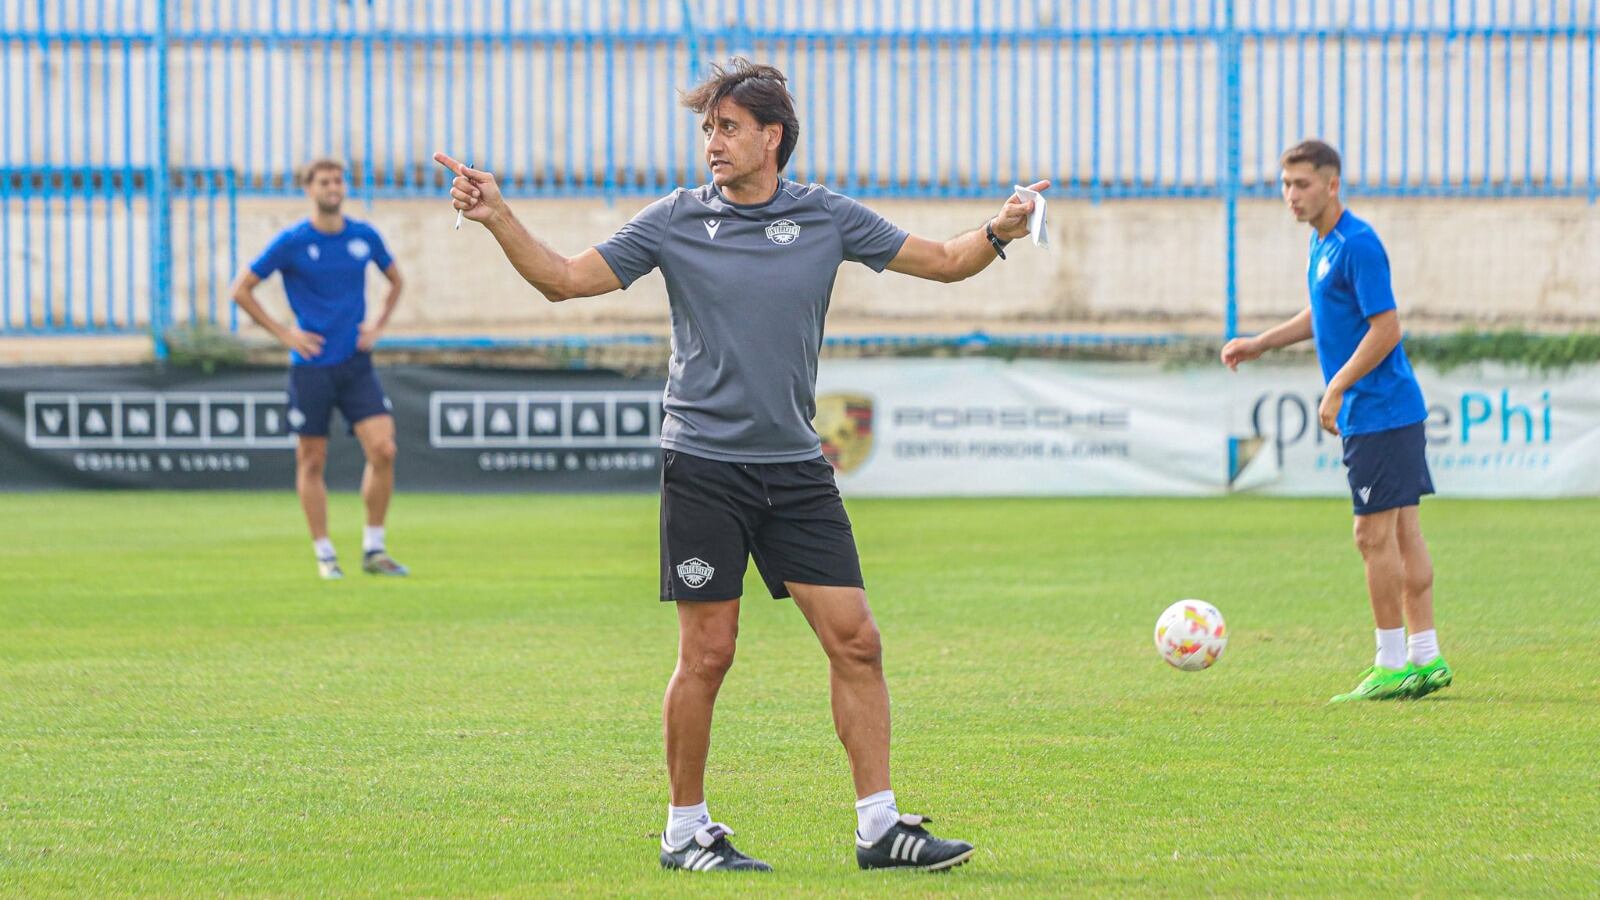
[[595, 181, 906, 463]]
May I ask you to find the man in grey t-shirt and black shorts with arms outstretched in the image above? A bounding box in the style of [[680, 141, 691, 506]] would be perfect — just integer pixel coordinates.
[[434, 59, 1050, 871]]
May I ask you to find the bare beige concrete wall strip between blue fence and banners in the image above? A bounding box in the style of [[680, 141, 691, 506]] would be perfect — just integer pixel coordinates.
[[216, 190, 1600, 331]]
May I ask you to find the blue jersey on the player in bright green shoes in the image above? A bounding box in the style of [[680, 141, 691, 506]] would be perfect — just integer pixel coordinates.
[[1306, 211, 1427, 437]]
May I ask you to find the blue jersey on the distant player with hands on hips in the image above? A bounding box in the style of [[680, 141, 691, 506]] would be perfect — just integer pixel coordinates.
[[250, 218, 394, 365]]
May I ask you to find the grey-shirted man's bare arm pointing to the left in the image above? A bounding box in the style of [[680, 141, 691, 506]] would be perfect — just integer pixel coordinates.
[[434, 154, 622, 303]]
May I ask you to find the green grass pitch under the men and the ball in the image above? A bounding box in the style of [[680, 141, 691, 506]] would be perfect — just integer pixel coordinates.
[[0, 493, 1600, 897]]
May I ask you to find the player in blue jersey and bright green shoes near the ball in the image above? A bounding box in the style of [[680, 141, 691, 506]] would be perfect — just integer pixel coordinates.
[[1222, 141, 1453, 703]]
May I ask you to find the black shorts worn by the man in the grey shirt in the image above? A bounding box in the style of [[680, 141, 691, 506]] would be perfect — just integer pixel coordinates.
[[661, 450, 864, 601]]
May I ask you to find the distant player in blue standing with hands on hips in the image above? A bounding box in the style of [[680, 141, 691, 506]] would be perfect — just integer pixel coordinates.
[[232, 159, 406, 578]]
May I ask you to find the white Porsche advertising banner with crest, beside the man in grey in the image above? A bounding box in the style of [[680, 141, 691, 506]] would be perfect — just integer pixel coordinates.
[[816, 359, 1227, 496]]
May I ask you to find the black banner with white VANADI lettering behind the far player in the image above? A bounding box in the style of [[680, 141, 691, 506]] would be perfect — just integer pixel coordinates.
[[0, 367, 662, 492]]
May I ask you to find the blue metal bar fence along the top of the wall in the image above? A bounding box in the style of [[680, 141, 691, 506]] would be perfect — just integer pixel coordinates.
[[0, 0, 1600, 350]]
